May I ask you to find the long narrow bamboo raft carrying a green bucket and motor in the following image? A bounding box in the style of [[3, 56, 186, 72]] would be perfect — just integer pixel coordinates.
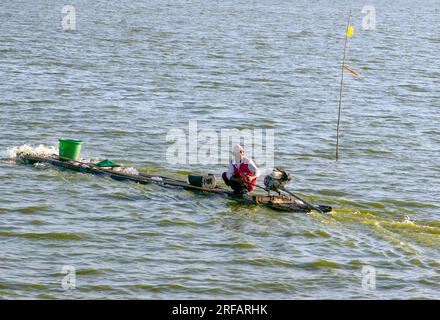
[[18, 154, 332, 213]]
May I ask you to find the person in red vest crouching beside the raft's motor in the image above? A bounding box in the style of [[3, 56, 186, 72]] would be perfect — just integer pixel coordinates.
[[222, 144, 260, 195]]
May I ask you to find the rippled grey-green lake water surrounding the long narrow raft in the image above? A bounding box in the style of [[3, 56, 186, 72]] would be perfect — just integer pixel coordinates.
[[0, 0, 440, 299]]
